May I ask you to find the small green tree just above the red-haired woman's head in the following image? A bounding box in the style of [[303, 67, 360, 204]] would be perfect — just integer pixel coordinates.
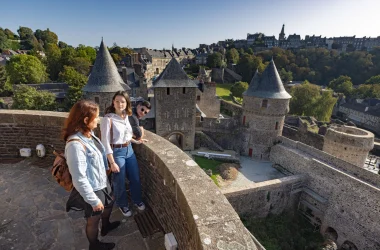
[[59, 66, 87, 109]]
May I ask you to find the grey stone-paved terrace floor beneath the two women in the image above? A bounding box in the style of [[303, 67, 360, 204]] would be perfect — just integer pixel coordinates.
[[0, 159, 164, 250]]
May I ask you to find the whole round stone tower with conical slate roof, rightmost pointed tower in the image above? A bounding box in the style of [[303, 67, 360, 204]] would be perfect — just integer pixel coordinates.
[[242, 59, 291, 160]]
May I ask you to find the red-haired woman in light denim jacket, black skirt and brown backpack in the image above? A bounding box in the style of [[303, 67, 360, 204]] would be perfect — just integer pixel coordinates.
[[63, 100, 120, 250]]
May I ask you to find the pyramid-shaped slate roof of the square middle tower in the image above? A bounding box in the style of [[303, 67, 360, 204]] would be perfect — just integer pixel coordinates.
[[153, 58, 198, 88]]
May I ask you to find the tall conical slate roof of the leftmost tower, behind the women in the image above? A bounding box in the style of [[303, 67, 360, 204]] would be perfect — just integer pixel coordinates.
[[82, 39, 131, 93]]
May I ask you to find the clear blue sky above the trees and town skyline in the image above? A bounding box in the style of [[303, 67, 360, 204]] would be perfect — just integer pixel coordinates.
[[0, 0, 380, 49]]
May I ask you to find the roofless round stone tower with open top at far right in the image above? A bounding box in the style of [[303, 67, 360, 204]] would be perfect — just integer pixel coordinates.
[[323, 126, 374, 168]]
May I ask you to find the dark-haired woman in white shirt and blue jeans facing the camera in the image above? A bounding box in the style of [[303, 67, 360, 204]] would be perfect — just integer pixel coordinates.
[[100, 91, 145, 217]]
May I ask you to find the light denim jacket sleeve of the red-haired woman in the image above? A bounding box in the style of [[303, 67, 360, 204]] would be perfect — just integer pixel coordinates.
[[65, 142, 101, 207]]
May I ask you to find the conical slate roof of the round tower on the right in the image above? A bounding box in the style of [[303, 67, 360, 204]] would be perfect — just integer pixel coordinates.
[[243, 59, 292, 99]]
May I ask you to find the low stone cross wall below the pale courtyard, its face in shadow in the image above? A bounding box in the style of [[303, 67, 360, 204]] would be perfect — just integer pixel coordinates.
[[224, 175, 306, 218]]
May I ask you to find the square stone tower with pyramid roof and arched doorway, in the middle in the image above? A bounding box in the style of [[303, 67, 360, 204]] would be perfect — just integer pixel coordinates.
[[153, 58, 197, 150]]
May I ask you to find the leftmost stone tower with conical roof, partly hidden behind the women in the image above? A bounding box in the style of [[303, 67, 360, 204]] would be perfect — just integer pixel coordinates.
[[82, 39, 131, 115]]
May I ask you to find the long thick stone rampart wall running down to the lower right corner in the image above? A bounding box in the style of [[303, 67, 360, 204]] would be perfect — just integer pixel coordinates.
[[270, 137, 380, 249]]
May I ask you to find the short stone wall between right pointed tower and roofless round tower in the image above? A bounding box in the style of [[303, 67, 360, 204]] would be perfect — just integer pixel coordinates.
[[282, 124, 324, 150]]
